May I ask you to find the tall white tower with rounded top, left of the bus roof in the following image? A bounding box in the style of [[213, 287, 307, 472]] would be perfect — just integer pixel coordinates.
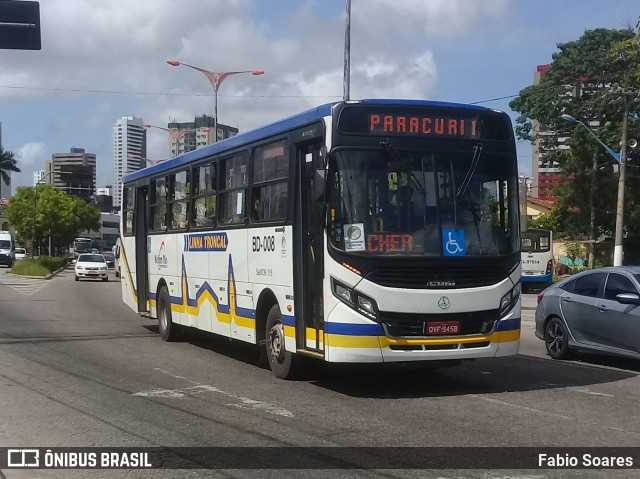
[[112, 116, 147, 207]]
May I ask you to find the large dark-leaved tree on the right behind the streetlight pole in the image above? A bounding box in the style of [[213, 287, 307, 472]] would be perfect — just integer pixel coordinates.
[[510, 29, 640, 238]]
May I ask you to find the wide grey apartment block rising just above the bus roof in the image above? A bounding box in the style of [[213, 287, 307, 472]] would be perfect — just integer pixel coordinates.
[[167, 115, 238, 157]]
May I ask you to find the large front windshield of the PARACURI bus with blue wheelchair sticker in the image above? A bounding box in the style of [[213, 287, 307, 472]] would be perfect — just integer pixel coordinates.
[[329, 145, 519, 256]]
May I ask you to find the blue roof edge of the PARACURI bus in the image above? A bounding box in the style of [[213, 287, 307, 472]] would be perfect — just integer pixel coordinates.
[[122, 99, 497, 183]]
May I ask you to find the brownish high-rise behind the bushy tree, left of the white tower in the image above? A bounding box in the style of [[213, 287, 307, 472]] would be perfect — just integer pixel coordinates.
[[51, 148, 96, 201]]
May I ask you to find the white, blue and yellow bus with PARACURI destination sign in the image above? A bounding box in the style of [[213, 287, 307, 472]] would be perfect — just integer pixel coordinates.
[[120, 100, 521, 378]]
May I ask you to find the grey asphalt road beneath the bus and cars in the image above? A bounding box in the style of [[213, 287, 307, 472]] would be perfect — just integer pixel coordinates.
[[0, 268, 640, 479]]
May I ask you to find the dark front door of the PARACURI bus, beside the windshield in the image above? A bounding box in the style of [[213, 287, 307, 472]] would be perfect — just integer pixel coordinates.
[[294, 144, 324, 354]]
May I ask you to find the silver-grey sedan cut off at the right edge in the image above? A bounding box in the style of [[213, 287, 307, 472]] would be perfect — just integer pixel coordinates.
[[536, 266, 640, 359]]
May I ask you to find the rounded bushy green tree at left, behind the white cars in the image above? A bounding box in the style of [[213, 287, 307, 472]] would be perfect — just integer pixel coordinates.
[[7, 184, 100, 255]]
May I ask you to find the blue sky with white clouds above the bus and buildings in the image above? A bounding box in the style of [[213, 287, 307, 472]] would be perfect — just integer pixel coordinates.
[[0, 0, 640, 196]]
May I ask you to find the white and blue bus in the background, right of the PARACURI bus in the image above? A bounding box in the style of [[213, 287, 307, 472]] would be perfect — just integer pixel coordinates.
[[521, 229, 553, 289]]
